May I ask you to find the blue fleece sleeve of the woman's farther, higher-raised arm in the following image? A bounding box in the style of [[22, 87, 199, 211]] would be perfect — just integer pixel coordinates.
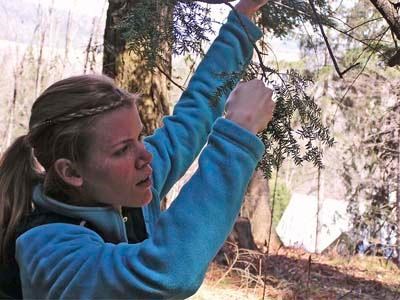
[[145, 12, 261, 199]]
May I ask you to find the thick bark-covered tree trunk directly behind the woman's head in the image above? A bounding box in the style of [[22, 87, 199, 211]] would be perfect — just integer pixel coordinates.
[[103, 0, 172, 134]]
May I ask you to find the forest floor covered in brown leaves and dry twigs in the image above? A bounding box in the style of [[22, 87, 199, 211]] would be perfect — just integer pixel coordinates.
[[190, 249, 400, 300]]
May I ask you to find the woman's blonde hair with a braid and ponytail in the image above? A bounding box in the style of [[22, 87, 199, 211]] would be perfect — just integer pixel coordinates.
[[0, 75, 134, 262]]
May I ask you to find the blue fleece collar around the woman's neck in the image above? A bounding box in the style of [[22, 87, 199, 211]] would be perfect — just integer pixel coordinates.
[[33, 184, 128, 243]]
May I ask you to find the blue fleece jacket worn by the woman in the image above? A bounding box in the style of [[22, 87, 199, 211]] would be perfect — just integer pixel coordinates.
[[16, 13, 264, 299]]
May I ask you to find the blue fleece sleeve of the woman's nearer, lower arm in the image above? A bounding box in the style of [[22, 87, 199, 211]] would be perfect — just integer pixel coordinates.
[[16, 119, 264, 299]]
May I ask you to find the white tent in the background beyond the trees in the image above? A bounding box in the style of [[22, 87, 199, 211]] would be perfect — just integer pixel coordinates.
[[276, 193, 349, 253]]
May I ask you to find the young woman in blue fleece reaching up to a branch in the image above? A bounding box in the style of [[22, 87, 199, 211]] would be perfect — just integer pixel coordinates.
[[0, 0, 274, 299]]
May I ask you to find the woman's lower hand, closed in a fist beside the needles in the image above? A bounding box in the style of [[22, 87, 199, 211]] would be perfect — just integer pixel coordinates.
[[225, 79, 275, 134]]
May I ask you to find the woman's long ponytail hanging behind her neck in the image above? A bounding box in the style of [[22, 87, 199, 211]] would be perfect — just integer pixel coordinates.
[[0, 136, 39, 263]]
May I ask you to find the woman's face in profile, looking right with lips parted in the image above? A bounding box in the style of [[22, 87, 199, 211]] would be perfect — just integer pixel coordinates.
[[80, 104, 152, 207]]
